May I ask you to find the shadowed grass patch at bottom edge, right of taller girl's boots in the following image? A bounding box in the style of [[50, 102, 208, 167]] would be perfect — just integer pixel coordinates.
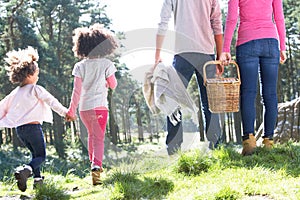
[[104, 172, 174, 199]]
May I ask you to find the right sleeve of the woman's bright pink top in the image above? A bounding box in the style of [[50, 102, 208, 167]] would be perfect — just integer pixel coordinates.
[[273, 0, 286, 51]]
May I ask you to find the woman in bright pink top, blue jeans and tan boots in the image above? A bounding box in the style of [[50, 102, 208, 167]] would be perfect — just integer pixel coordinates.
[[220, 0, 286, 155]]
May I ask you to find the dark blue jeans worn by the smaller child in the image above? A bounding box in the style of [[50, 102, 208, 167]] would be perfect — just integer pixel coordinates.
[[17, 124, 46, 178]]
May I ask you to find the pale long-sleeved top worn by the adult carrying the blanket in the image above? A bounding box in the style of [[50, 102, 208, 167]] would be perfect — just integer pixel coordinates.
[[157, 0, 223, 54]]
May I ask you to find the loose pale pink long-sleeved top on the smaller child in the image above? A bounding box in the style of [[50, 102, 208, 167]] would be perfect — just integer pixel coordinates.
[[0, 84, 68, 128]]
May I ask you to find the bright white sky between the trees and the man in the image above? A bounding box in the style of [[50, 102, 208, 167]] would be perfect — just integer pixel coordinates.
[[102, 0, 173, 75]]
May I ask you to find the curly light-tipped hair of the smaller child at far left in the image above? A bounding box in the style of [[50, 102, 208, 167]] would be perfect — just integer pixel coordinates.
[[5, 46, 39, 84]]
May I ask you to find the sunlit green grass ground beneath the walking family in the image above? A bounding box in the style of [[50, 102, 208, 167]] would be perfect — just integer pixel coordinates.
[[0, 142, 300, 200]]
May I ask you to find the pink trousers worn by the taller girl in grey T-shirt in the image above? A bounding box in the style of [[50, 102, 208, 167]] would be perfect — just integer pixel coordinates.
[[80, 110, 108, 167]]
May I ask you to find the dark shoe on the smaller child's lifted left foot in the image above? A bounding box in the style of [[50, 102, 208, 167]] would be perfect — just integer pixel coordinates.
[[15, 165, 32, 192]]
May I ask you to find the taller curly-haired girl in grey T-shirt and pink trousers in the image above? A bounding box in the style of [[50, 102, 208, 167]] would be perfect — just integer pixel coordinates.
[[68, 24, 117, 185]]
